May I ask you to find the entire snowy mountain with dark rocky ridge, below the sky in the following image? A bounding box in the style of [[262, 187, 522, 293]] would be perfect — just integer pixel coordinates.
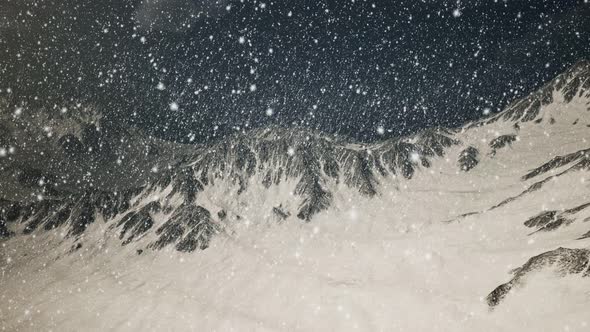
[[0, 61, 590, 331]]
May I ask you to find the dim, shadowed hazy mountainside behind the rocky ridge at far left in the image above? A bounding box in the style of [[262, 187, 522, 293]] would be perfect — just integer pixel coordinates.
[[0, 100, 194, 202]]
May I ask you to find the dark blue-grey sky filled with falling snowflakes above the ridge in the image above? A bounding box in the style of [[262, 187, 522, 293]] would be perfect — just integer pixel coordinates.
[[0, 0, 590, 141]]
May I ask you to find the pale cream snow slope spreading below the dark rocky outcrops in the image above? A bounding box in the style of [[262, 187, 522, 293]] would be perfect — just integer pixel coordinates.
[[0, 61, 590, 331]]
